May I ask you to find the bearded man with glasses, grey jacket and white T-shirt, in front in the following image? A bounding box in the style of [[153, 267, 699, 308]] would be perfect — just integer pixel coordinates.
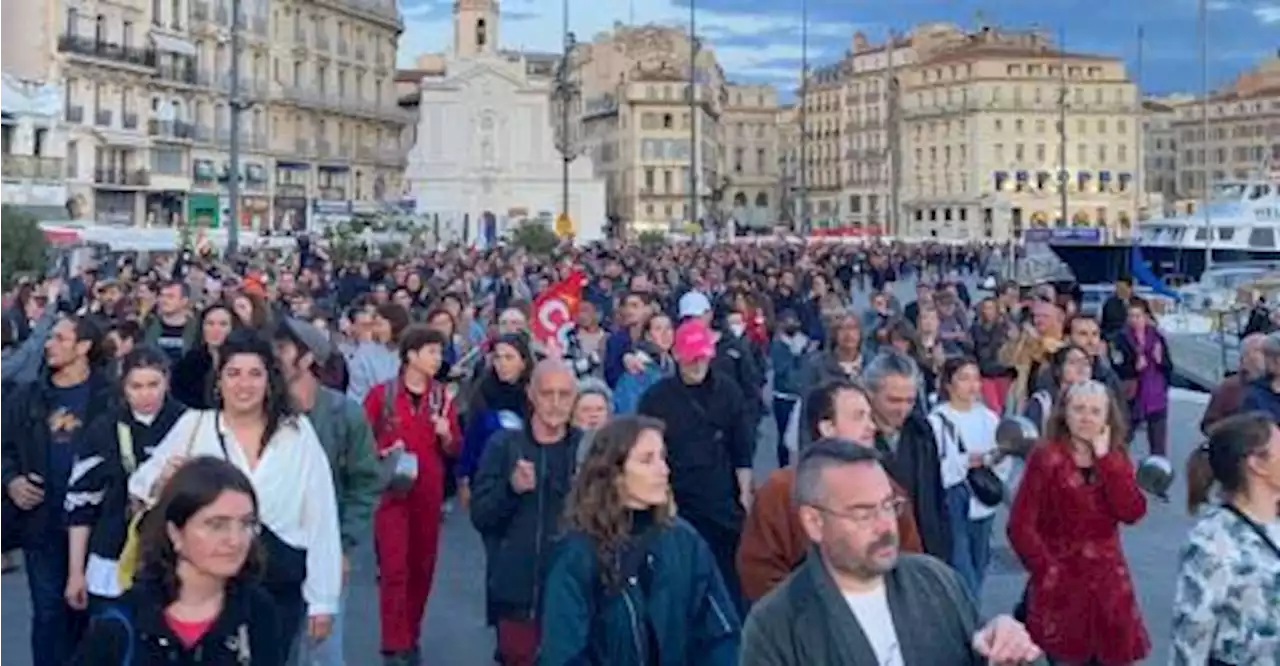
[[741, 439, 1041, 666]]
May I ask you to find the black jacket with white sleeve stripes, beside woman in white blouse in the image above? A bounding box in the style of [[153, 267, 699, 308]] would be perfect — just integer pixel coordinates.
[[65, 398, 186, 560]]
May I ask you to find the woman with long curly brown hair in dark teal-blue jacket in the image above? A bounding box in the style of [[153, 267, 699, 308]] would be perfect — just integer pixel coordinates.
[[538, 416, 741, 666]]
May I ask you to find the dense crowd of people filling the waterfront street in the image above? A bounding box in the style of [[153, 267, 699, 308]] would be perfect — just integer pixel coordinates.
[[0, 236, 1280, 666]]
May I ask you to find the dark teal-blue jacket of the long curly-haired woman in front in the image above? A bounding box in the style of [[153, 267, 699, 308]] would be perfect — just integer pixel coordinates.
[[538, 519, 741, 666]]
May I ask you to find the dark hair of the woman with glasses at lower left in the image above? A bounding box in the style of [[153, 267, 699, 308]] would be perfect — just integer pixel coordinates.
[[137, 456, 262, 606]]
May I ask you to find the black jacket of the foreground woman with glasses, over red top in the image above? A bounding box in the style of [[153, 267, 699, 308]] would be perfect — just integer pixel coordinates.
[[72, 580, 282, 666]]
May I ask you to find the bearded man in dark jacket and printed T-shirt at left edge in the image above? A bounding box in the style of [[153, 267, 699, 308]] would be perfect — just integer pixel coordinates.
[[0, 316, 114, 666]]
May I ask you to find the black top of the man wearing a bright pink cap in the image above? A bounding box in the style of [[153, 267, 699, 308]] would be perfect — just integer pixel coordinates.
[[636, 364, 755, 532]]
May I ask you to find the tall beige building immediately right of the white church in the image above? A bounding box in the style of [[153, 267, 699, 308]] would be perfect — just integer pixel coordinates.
[[570, 23, 737, 233]]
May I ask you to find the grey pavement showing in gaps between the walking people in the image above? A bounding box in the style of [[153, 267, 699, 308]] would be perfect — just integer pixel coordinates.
[[0, 272, 1207, 666]]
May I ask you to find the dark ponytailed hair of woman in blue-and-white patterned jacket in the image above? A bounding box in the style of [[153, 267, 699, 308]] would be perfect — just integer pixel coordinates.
[[1187, 411, 1275, 514]]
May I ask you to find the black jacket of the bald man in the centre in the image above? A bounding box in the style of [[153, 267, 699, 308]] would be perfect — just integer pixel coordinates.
[[471, 429, 581, 620]]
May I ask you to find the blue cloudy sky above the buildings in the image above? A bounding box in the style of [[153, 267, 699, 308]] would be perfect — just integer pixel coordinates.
[[399, 0, 1280, 95]]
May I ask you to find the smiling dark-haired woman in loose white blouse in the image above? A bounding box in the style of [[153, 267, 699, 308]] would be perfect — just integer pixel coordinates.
[[129, 330, 342, 653]]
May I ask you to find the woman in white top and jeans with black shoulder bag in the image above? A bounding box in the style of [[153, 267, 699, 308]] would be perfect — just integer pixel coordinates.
[[929, 357, 1012, 599]]
